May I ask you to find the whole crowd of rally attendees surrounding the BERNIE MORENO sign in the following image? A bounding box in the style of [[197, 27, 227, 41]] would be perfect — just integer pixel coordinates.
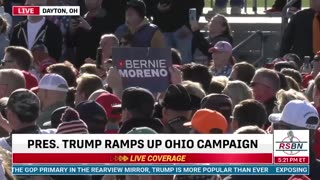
[[0, 0, 320, 180]]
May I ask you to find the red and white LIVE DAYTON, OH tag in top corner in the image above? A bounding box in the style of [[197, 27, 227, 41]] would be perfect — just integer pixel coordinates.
[[12, 6, 80, 16]]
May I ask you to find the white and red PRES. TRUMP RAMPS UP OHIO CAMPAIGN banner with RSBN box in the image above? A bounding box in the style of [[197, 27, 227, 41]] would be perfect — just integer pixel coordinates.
[[12, 130, 309, 165]]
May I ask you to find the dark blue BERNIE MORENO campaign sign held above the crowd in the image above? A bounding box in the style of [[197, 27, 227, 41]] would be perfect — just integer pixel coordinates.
[[112, 48, 172, 92]]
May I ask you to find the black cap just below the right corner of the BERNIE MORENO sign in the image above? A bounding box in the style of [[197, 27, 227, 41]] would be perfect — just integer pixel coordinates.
[[161, 84, 193, 111]]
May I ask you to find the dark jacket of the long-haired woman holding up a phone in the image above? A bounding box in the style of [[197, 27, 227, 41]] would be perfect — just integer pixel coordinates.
[[192, 31, 233, 59]]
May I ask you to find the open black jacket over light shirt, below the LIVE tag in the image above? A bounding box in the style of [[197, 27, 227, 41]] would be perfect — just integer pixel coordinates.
[[10, 20, 62, 60]]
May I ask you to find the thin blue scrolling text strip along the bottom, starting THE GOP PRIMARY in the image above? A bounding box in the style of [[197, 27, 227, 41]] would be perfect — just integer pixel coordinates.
[[12, 165, 310, 175]]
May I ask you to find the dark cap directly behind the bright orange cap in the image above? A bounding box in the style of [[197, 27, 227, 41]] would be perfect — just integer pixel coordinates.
[[201, 93, 232, 122]]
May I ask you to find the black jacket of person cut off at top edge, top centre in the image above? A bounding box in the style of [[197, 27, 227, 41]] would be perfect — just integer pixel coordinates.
[[151, 0, 204, 32]]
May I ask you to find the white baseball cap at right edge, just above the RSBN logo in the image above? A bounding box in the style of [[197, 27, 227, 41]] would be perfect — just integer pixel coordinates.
[[269, 100, 319, 129]]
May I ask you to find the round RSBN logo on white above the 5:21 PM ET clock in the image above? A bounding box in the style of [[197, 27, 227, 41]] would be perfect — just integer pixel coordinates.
[[276, 131, 308, 155]]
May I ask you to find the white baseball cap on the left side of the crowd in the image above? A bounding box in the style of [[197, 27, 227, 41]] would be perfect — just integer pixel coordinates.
[[39, 73, 69, 92]]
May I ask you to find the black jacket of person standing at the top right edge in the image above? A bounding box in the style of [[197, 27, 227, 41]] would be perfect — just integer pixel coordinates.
[[280, 9, 315, 59]]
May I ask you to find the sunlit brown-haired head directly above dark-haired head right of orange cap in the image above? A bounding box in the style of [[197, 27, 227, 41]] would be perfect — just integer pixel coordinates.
[[222, 80, 253, 107]]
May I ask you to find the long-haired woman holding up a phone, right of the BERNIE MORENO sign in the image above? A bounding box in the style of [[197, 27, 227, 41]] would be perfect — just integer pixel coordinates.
[[191, 14, 233, 59]]
